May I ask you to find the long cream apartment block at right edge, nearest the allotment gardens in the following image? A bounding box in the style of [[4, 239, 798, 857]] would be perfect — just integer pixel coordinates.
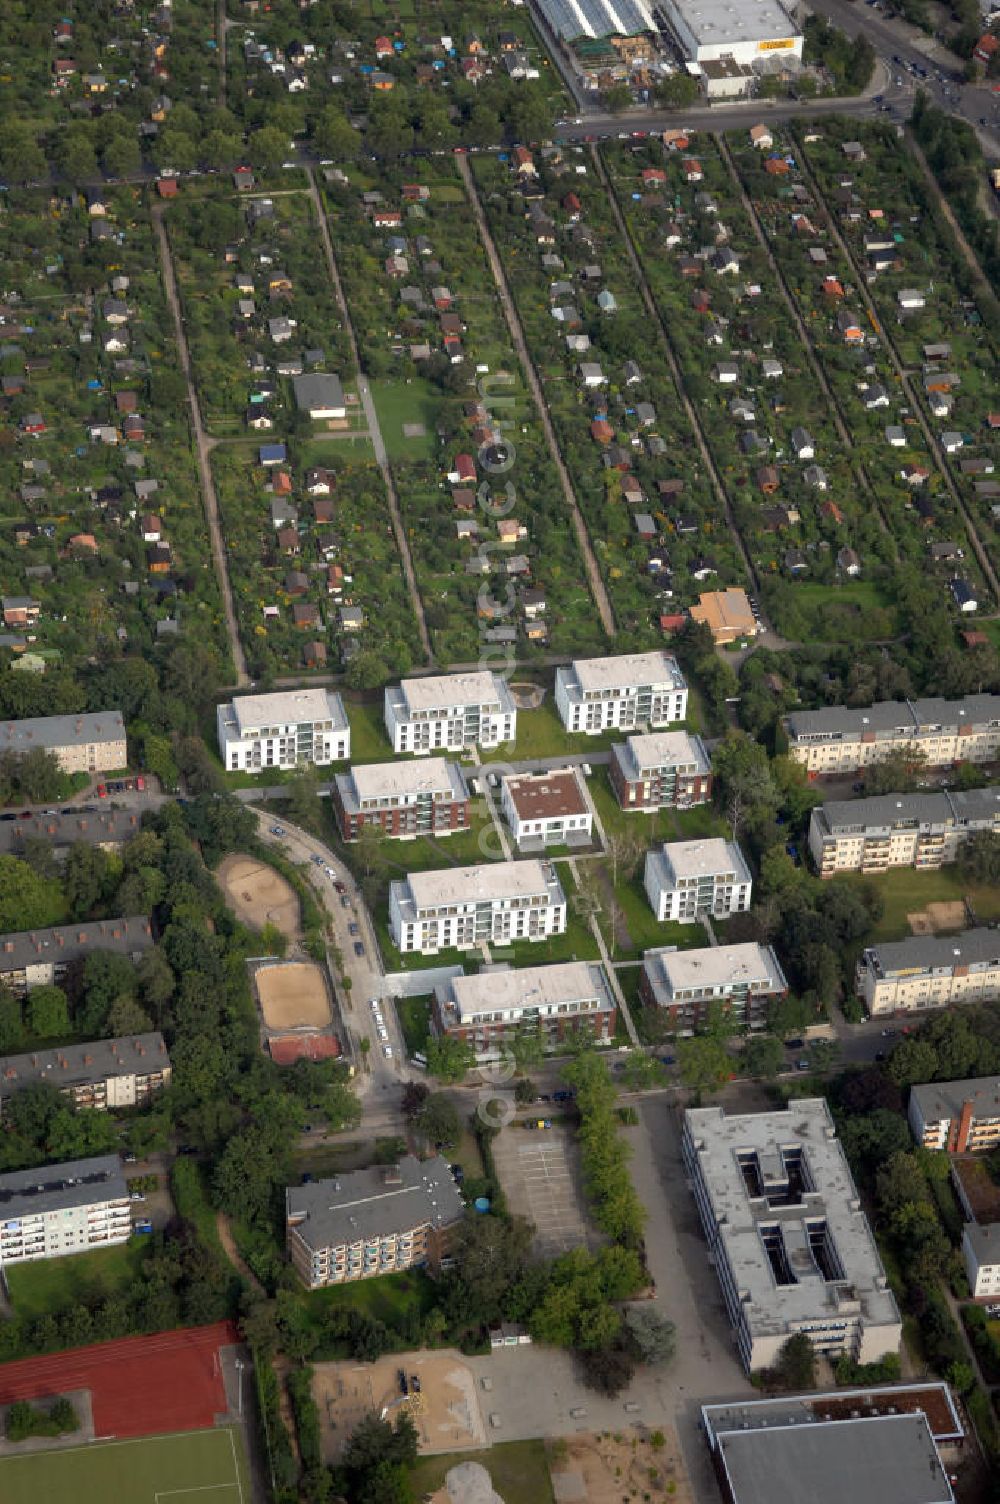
[[782, 695, 1000, 776]]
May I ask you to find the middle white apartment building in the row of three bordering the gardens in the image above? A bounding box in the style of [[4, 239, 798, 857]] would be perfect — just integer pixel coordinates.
[[378, 669, 517, 754]]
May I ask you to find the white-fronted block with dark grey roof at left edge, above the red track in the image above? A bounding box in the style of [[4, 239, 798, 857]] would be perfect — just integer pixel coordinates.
[[0, 1154, 132, 1268]]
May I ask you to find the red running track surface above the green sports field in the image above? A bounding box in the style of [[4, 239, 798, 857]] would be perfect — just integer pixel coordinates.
[[0, 1322, 239, 1436]]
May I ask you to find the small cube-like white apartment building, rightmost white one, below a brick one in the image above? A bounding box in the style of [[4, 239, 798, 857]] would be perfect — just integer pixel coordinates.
[[644, 836, 752, 923]]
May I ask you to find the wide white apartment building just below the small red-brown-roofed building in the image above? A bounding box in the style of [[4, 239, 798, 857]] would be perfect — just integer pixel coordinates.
[[389, 860, 565, 955]]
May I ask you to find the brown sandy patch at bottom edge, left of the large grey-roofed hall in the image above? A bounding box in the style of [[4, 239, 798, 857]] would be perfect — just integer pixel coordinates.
[[549, 1426, 693, 1504]]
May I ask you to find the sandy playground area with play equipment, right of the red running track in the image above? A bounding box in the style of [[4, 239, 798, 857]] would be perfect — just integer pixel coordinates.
[[313, 1352, 486, 1463]]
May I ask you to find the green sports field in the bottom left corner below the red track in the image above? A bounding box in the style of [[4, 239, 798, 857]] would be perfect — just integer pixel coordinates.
[[0, 1427, 250, 1504]]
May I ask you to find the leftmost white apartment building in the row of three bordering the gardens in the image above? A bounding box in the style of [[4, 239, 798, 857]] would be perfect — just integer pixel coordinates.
[[215, 687, 350, 773]]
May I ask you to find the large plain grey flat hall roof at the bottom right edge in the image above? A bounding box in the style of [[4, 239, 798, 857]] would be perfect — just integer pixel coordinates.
[[702, 1402, 955, 1504]]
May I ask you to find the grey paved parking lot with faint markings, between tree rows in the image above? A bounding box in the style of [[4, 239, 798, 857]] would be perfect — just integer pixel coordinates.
[[493, 1123, 595, 1257]]
